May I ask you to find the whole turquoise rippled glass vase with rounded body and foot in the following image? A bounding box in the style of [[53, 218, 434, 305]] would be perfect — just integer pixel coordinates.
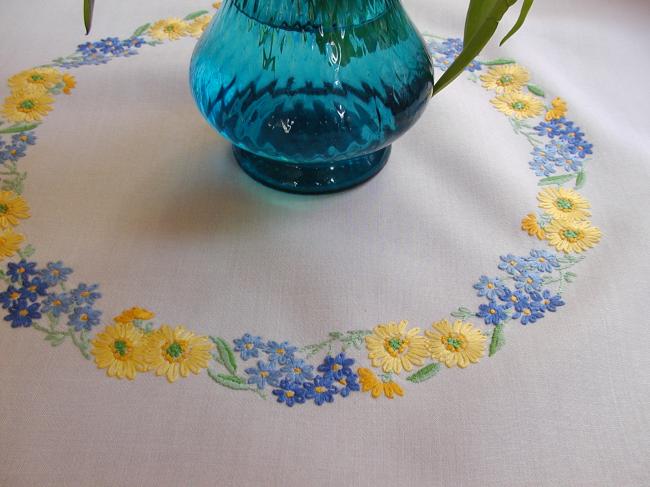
[[190, 0, 433, 193]]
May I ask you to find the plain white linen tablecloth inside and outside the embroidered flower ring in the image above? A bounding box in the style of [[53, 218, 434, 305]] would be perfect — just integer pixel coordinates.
[[0, 0, 650, 486]]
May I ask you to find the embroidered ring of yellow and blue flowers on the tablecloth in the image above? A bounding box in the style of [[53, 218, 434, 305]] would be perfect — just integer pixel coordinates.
[[0, 4, 601, 407]]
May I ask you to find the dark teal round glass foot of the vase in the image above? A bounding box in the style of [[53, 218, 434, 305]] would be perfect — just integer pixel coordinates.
[[233, 145, 390, 194]]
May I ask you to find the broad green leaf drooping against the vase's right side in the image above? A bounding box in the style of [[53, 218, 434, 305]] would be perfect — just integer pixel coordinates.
[[433, 0, 517, 95]]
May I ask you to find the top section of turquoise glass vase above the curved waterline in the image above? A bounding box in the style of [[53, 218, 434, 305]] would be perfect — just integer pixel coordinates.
[[226, 0, 399, 31]]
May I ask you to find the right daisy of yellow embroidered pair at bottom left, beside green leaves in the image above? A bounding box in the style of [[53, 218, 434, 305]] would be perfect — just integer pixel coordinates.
[[146, 325, 213, 383]]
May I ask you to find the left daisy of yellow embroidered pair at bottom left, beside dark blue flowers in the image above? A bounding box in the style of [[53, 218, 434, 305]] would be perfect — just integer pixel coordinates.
[[90, 323, 147, 380]]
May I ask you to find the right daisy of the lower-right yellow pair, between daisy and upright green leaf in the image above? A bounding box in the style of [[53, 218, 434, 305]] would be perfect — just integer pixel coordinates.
[[424, 320, 486, 368]]
